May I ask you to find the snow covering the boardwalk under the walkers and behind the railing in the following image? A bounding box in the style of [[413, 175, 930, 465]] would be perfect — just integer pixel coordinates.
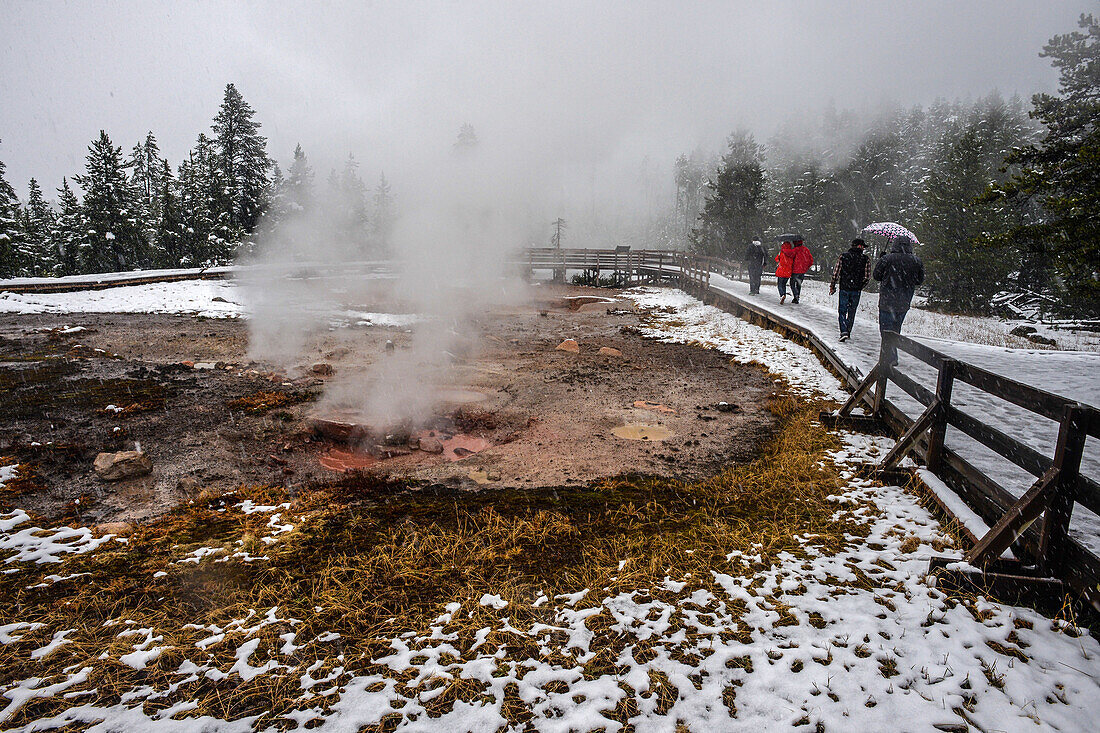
[[696, 275, 1100, 555]]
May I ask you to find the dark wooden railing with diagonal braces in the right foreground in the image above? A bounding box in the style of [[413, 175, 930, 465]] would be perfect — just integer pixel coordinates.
[[838, 331, 1100, 603]]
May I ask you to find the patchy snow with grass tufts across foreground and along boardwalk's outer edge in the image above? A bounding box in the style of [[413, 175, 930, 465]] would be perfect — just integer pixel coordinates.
[[0, 299, 1100, 733]]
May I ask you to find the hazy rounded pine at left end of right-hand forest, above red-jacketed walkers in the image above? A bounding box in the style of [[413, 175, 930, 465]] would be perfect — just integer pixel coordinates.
[[701, 130, 766, 258]]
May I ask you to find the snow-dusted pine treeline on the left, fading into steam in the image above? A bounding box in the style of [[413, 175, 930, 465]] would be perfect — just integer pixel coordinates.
[[0, 84, 394, 277]]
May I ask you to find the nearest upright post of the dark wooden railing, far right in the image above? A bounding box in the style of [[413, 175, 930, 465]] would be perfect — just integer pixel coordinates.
[[1038, 405, 1088, 576]]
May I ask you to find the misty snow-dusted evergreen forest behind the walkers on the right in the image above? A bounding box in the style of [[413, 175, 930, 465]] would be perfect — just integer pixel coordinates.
[[675, 15, 1100, 315]]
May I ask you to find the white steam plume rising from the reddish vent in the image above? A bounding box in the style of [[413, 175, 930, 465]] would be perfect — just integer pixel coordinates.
[[242, 136, 530, 429]]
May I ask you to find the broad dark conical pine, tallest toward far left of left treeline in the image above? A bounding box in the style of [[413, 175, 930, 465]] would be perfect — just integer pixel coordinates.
[[74, 130, 149, 272]]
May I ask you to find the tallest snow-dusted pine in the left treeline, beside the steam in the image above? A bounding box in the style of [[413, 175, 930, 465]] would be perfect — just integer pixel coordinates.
[[213, 84, 272, 233]]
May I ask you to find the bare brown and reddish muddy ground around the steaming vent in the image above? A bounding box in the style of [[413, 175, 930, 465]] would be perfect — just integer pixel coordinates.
[[0, 287, 774, 522]]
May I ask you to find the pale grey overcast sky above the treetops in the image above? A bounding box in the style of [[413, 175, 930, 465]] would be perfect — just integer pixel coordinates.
[[0, 0, 1095, 198]]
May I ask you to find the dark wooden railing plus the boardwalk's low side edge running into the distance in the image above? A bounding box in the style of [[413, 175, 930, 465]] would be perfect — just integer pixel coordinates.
[[660, 268, 1100, 609]]
